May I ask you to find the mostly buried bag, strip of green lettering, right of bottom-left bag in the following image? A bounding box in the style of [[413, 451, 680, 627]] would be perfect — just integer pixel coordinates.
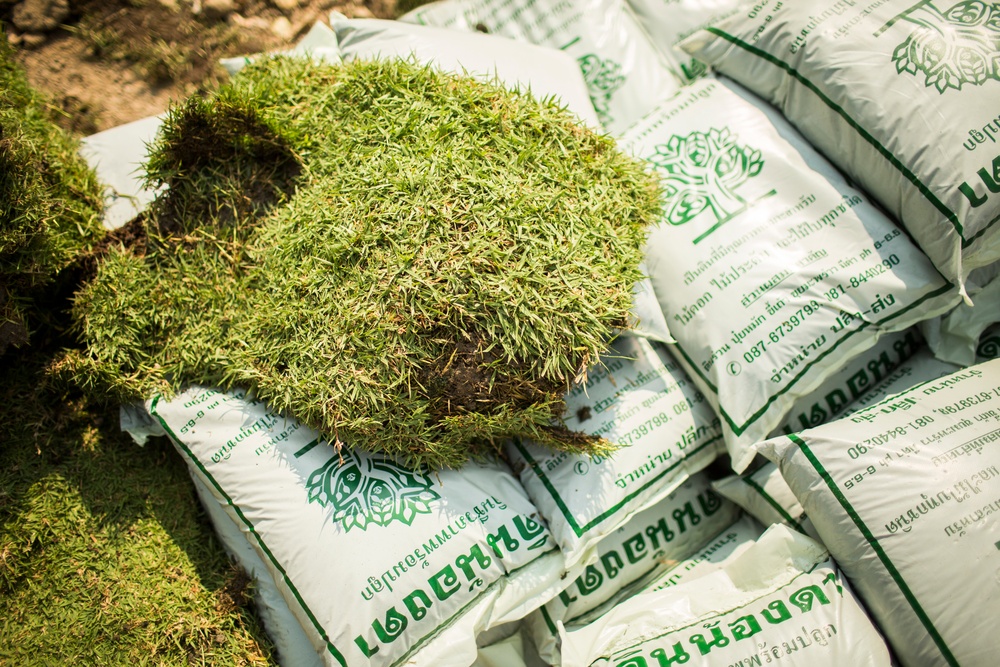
[[525, 473, 739, 663]]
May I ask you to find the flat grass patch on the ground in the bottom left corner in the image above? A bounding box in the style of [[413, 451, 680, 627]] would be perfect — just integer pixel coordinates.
[[0, 352, 276, 667]]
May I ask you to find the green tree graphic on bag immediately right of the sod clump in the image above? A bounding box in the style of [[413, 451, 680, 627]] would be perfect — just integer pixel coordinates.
[[647, 127, 773, 243]]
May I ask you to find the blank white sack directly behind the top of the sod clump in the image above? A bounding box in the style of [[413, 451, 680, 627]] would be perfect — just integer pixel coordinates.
[[331, 13, 601, 128]]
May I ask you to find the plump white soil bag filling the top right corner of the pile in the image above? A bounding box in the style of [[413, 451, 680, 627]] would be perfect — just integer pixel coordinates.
[[682, 0, 1000, 298]]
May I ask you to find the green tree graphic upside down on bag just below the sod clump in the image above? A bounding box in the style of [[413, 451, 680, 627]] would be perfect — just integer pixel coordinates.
[[306, 448, 440, 532]]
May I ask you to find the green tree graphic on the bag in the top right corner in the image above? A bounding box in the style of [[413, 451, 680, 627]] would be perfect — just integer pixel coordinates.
[[886, 0, 1000, 93]]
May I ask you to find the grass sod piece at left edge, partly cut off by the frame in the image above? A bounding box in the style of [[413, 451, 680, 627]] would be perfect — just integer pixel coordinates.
[[0, 40, 104, 355]]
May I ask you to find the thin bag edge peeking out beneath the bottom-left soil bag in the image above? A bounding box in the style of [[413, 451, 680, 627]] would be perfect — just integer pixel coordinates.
[[191, 474, 323, 667]]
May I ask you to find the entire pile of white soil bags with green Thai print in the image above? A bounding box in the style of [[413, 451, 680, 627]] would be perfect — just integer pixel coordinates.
[[86, 0, 1000, 667]]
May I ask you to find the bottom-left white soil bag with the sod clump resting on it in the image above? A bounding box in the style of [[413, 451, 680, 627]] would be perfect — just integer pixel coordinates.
[[125, 388, 565, 665]]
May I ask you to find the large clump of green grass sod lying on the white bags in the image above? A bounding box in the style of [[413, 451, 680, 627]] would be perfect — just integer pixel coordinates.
[[68, 59, 660, 467]]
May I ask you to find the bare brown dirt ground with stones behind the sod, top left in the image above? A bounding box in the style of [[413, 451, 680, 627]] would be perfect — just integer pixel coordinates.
[[0, 0, 402, 136]]
